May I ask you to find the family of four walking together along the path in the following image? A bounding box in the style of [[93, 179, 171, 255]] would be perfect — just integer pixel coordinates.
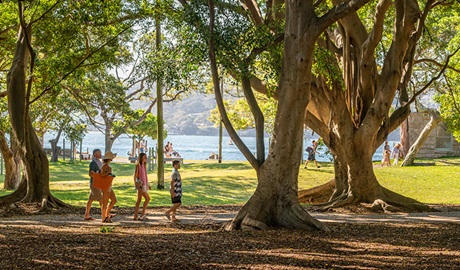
[[84, 149, 182, 223]]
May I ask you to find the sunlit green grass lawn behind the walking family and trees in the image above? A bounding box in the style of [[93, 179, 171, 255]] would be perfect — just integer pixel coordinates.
[[0, 158, 460, 207]]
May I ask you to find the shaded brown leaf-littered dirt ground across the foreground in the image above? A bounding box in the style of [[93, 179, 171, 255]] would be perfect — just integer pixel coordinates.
[[0, 206, 460, 269]]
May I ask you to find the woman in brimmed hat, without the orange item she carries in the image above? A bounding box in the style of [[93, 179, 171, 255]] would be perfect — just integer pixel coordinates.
[[101, 151, 117, 223]]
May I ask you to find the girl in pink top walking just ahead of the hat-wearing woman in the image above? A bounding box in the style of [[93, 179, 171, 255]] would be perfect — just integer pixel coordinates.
[[133, 153, 150, 220]]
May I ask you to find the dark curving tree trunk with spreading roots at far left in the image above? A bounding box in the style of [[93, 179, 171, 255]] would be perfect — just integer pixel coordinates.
[[0, 20, 65, 209]]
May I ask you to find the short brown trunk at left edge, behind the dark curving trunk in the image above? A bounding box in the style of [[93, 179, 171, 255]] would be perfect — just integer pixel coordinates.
[[0, 130, 21, 190]]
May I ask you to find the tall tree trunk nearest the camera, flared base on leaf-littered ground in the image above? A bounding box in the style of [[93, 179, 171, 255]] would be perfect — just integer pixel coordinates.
[[216, 0, 365, 231]]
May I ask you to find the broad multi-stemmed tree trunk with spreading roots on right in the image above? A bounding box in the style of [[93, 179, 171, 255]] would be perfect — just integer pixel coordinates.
[[296, 0, 440, 211]]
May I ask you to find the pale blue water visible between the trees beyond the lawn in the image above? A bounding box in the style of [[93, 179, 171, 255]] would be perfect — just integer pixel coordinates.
[[44, 132, 393, 162]]
